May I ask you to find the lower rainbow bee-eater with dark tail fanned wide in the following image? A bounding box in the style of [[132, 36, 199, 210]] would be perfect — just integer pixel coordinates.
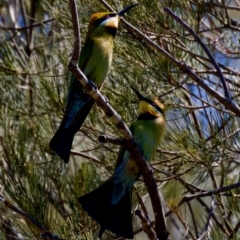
[[78, 88, 165, 238]]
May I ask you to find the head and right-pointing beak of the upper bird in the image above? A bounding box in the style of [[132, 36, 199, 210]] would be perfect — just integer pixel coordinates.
[[87, 3, 138, 38]]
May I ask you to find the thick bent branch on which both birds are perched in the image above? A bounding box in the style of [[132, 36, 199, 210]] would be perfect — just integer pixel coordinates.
[[69, 0, 169, 239]]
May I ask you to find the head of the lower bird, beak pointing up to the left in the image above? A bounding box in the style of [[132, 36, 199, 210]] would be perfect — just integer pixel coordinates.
[[131, 86, 165, 117]]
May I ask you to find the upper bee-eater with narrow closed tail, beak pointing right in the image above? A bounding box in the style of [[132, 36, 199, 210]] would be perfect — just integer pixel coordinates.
[[49, 3, 138, 163]]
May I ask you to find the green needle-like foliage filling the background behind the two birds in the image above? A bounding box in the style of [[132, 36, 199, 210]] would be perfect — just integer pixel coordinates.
[[0, 0, 240, 239]]
